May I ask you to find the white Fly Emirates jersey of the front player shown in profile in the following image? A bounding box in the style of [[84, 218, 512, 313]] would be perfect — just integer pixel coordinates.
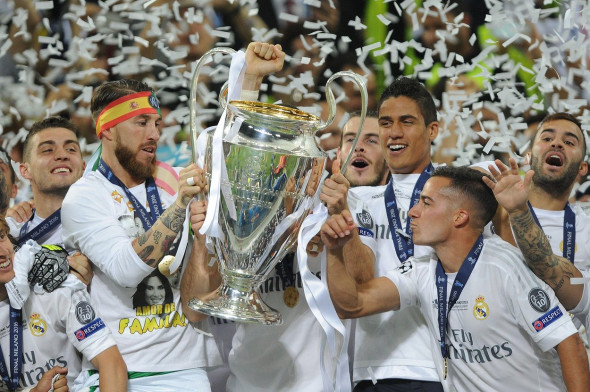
[[387, 237, 577, 392]]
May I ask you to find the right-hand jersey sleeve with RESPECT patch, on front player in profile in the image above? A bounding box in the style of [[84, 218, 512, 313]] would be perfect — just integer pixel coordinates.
[[506, 260, 577, 351]]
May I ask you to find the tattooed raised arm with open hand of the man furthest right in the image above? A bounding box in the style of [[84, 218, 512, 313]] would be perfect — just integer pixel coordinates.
[[483, 158, 584, 309]]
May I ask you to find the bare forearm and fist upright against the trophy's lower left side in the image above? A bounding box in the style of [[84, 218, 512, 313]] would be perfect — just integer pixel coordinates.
[[180, 201, 221, 322]]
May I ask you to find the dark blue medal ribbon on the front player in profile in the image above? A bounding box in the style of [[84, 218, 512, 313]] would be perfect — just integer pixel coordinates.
[[436, 235, 483, 358]]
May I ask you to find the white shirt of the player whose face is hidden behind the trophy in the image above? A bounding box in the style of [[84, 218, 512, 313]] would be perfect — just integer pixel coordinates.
[[227, 253, 335, 392]]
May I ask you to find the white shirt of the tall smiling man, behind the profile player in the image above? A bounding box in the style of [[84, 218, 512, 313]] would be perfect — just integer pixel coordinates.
[[348, 174, 440, 382]]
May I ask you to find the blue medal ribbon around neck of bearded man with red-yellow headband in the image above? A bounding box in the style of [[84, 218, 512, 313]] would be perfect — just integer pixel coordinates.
[[98, 158, 163, 231]]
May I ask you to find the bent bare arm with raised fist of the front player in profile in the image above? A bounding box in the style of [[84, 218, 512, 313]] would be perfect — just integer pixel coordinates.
[[321, 210, 400, 318]]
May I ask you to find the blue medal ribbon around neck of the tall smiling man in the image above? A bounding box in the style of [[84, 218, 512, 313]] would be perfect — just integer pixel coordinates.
[[383, 163, 434, 263]]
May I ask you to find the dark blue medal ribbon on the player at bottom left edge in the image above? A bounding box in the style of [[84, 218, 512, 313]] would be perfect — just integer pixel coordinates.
[[0, 306, 23, 391]]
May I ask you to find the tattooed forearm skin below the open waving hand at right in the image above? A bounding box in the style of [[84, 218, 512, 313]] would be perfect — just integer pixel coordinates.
[[510, 209, 574, 293]]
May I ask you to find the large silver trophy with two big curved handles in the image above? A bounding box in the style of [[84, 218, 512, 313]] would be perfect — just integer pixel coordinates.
[[188, 48, 367, 324]]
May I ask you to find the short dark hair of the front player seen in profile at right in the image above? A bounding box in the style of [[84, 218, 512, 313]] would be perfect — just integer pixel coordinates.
[[432, 166, 498, 228]]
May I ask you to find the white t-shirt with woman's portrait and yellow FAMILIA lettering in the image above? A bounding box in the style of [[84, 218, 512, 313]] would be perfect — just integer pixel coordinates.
[[62, 172, 220, 372]]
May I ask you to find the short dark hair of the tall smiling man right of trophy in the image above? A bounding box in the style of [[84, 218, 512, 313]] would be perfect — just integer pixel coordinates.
[[377, 76, 436, 126]]
